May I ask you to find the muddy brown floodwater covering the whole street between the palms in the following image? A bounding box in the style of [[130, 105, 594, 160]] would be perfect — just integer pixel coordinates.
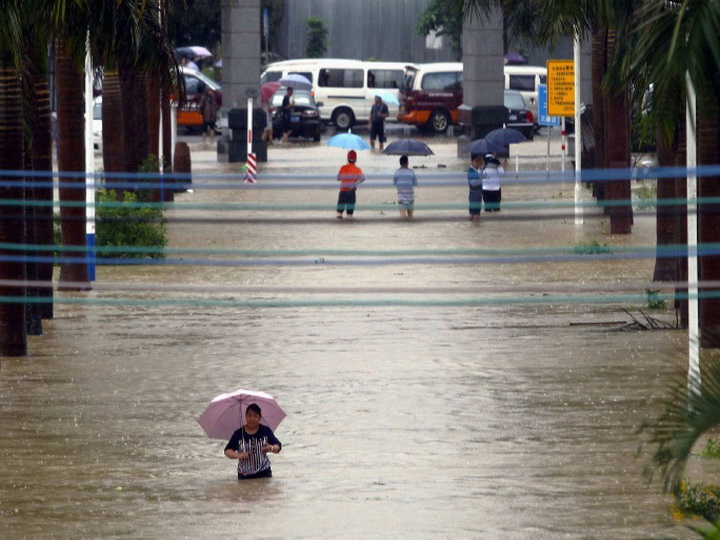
[[0, 130, 693, 539]]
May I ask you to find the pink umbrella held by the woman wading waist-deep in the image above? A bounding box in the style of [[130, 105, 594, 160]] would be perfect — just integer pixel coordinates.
[[198, 390, 286, 440]]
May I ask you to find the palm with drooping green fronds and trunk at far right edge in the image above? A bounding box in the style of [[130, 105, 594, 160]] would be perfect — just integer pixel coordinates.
[[628, 0, 720, 348]]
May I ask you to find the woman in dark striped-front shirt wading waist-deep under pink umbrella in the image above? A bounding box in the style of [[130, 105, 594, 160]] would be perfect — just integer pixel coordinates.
[[225, 403, 282, 480]]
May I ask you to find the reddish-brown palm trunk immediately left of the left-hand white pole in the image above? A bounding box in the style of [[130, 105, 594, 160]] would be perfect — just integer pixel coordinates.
[[55, 40, 91, 290]]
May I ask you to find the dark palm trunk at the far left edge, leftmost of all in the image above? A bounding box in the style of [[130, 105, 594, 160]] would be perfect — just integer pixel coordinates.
[[0, 63, 27, 356]]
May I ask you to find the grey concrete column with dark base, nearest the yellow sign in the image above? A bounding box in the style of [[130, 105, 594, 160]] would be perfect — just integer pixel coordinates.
[[459, 9, 507, 139]]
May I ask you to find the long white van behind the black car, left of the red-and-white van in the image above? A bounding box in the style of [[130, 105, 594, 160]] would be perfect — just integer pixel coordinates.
[[260, 58, 408, 130]]
